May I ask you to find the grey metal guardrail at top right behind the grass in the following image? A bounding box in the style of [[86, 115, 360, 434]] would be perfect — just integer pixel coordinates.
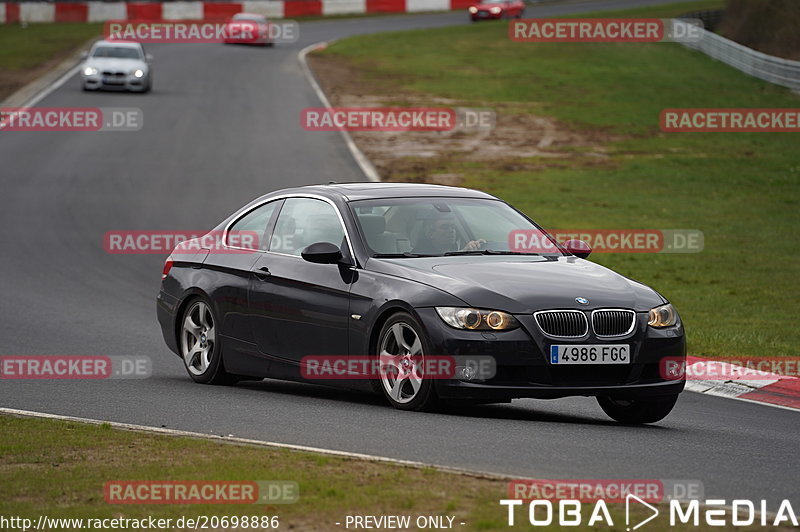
[[676, 17, 800, 91]]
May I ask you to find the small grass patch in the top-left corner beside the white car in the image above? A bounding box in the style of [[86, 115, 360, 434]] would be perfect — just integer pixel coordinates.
[[0, 23, 103, 70]]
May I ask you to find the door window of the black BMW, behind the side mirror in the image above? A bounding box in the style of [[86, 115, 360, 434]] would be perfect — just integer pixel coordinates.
[[269, 198, 344, 257]]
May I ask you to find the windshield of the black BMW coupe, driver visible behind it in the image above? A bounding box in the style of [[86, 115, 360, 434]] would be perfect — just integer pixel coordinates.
[[350, 197, 563, 257]]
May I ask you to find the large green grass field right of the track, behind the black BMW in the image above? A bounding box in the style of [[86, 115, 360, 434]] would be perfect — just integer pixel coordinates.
[[323, 1, 800, 356]]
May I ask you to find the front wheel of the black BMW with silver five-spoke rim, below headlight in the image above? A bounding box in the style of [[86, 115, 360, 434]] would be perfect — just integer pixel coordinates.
[[377, 312, 439, 411]]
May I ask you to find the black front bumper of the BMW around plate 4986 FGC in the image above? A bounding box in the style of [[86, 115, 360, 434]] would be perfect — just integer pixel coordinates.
[[417, 308, 686, 400]]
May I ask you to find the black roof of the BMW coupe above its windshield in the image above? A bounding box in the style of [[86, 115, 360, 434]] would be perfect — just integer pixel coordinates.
[[269, 182, 497, 201]]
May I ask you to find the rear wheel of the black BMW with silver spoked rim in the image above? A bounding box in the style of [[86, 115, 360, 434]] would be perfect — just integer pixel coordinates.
[[178, 297, 235, 384]]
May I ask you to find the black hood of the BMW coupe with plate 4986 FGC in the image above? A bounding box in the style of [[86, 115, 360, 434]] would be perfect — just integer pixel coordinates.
[[370, 256, 665, 314]]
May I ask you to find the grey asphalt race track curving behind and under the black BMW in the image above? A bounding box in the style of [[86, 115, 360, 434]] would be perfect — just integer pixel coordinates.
[[0, 0, 800, 510]]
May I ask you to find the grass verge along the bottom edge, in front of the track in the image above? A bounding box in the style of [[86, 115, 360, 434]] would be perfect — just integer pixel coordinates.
[[0, 416, 768, 531]]
